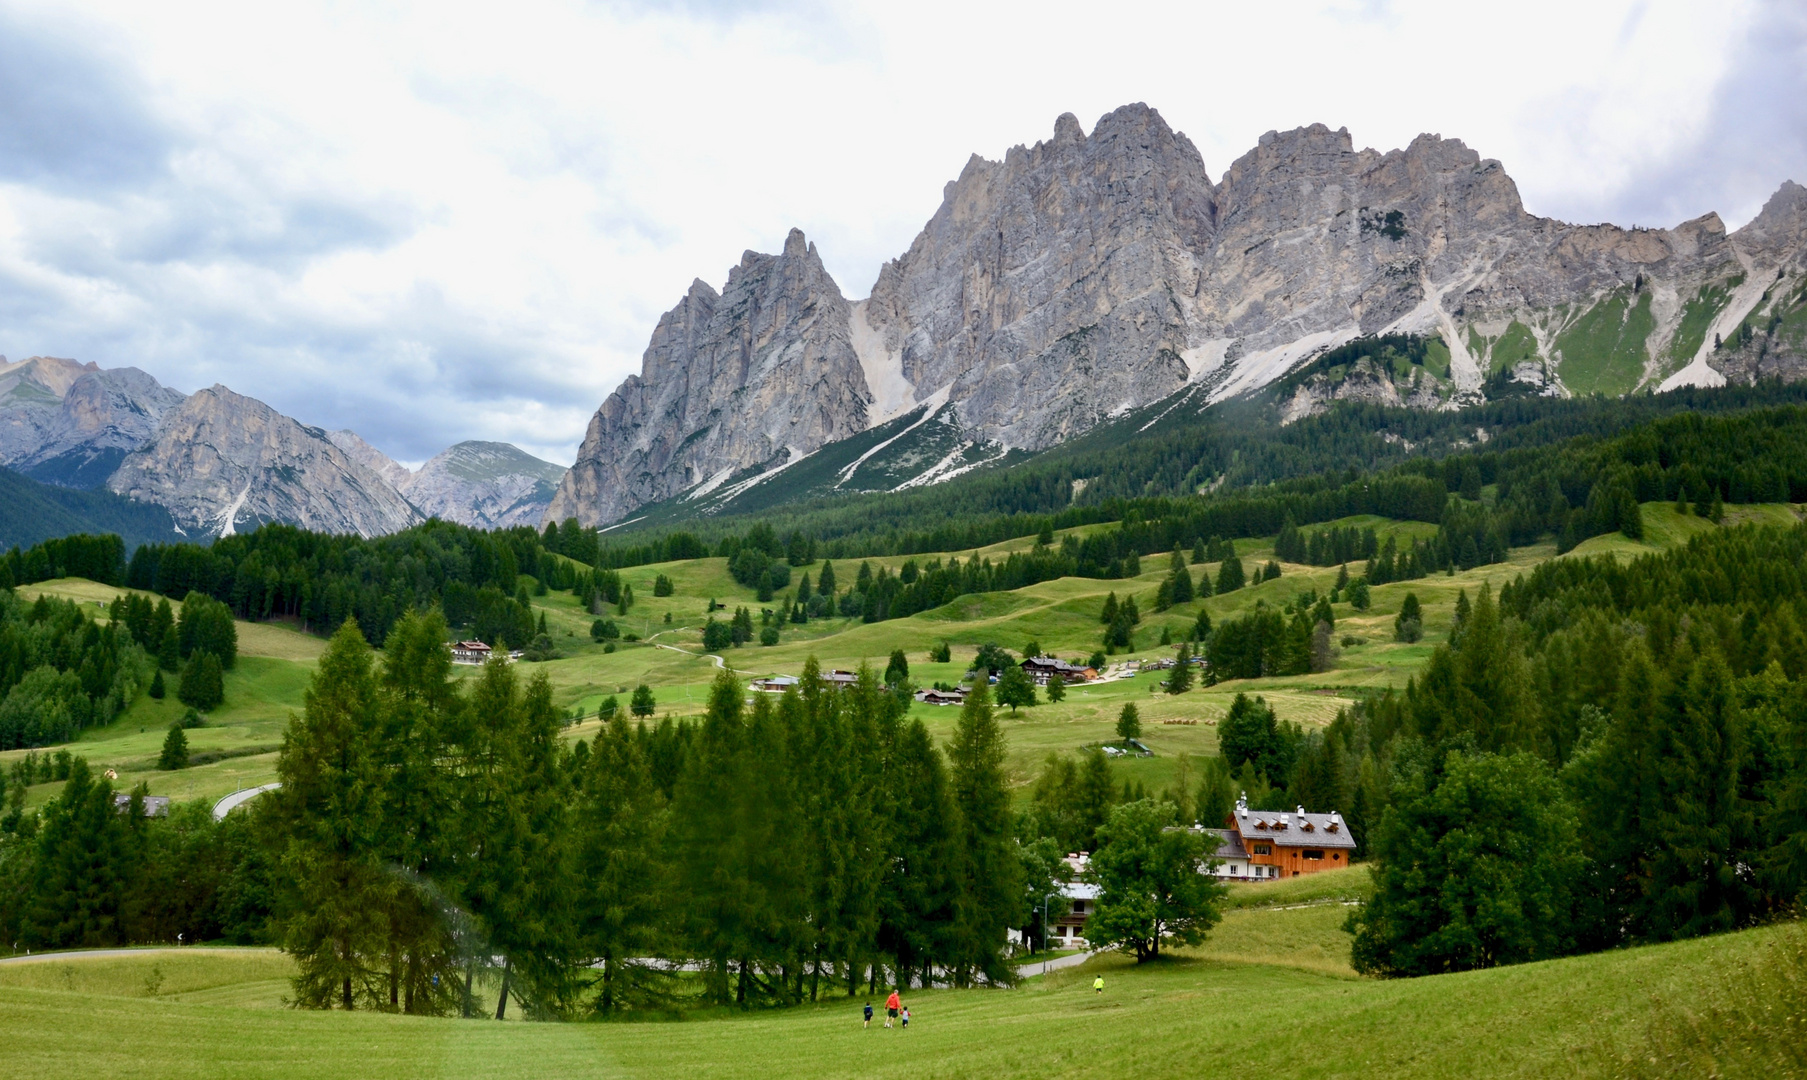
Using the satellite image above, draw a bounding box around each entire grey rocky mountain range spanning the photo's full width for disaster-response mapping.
[0,105,1807,536]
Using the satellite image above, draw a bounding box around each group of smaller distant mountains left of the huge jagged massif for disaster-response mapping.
[0,356,564,538]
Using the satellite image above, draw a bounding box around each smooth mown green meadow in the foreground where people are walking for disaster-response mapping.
[0,905,1807,1080]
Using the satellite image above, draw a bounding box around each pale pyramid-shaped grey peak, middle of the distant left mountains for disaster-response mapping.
[107,386,421,536]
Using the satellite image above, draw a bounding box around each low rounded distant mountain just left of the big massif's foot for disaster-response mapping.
[398,441,566,529]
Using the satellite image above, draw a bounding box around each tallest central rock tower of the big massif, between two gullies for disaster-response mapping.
[864,105,1216,450]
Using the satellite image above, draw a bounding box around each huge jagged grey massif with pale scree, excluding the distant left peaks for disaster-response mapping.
[548,105,1807,526]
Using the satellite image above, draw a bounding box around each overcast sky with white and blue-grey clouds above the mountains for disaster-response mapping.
[0,0,1807,462]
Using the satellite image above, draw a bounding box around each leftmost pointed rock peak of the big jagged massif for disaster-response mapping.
[546,229,873,526]
